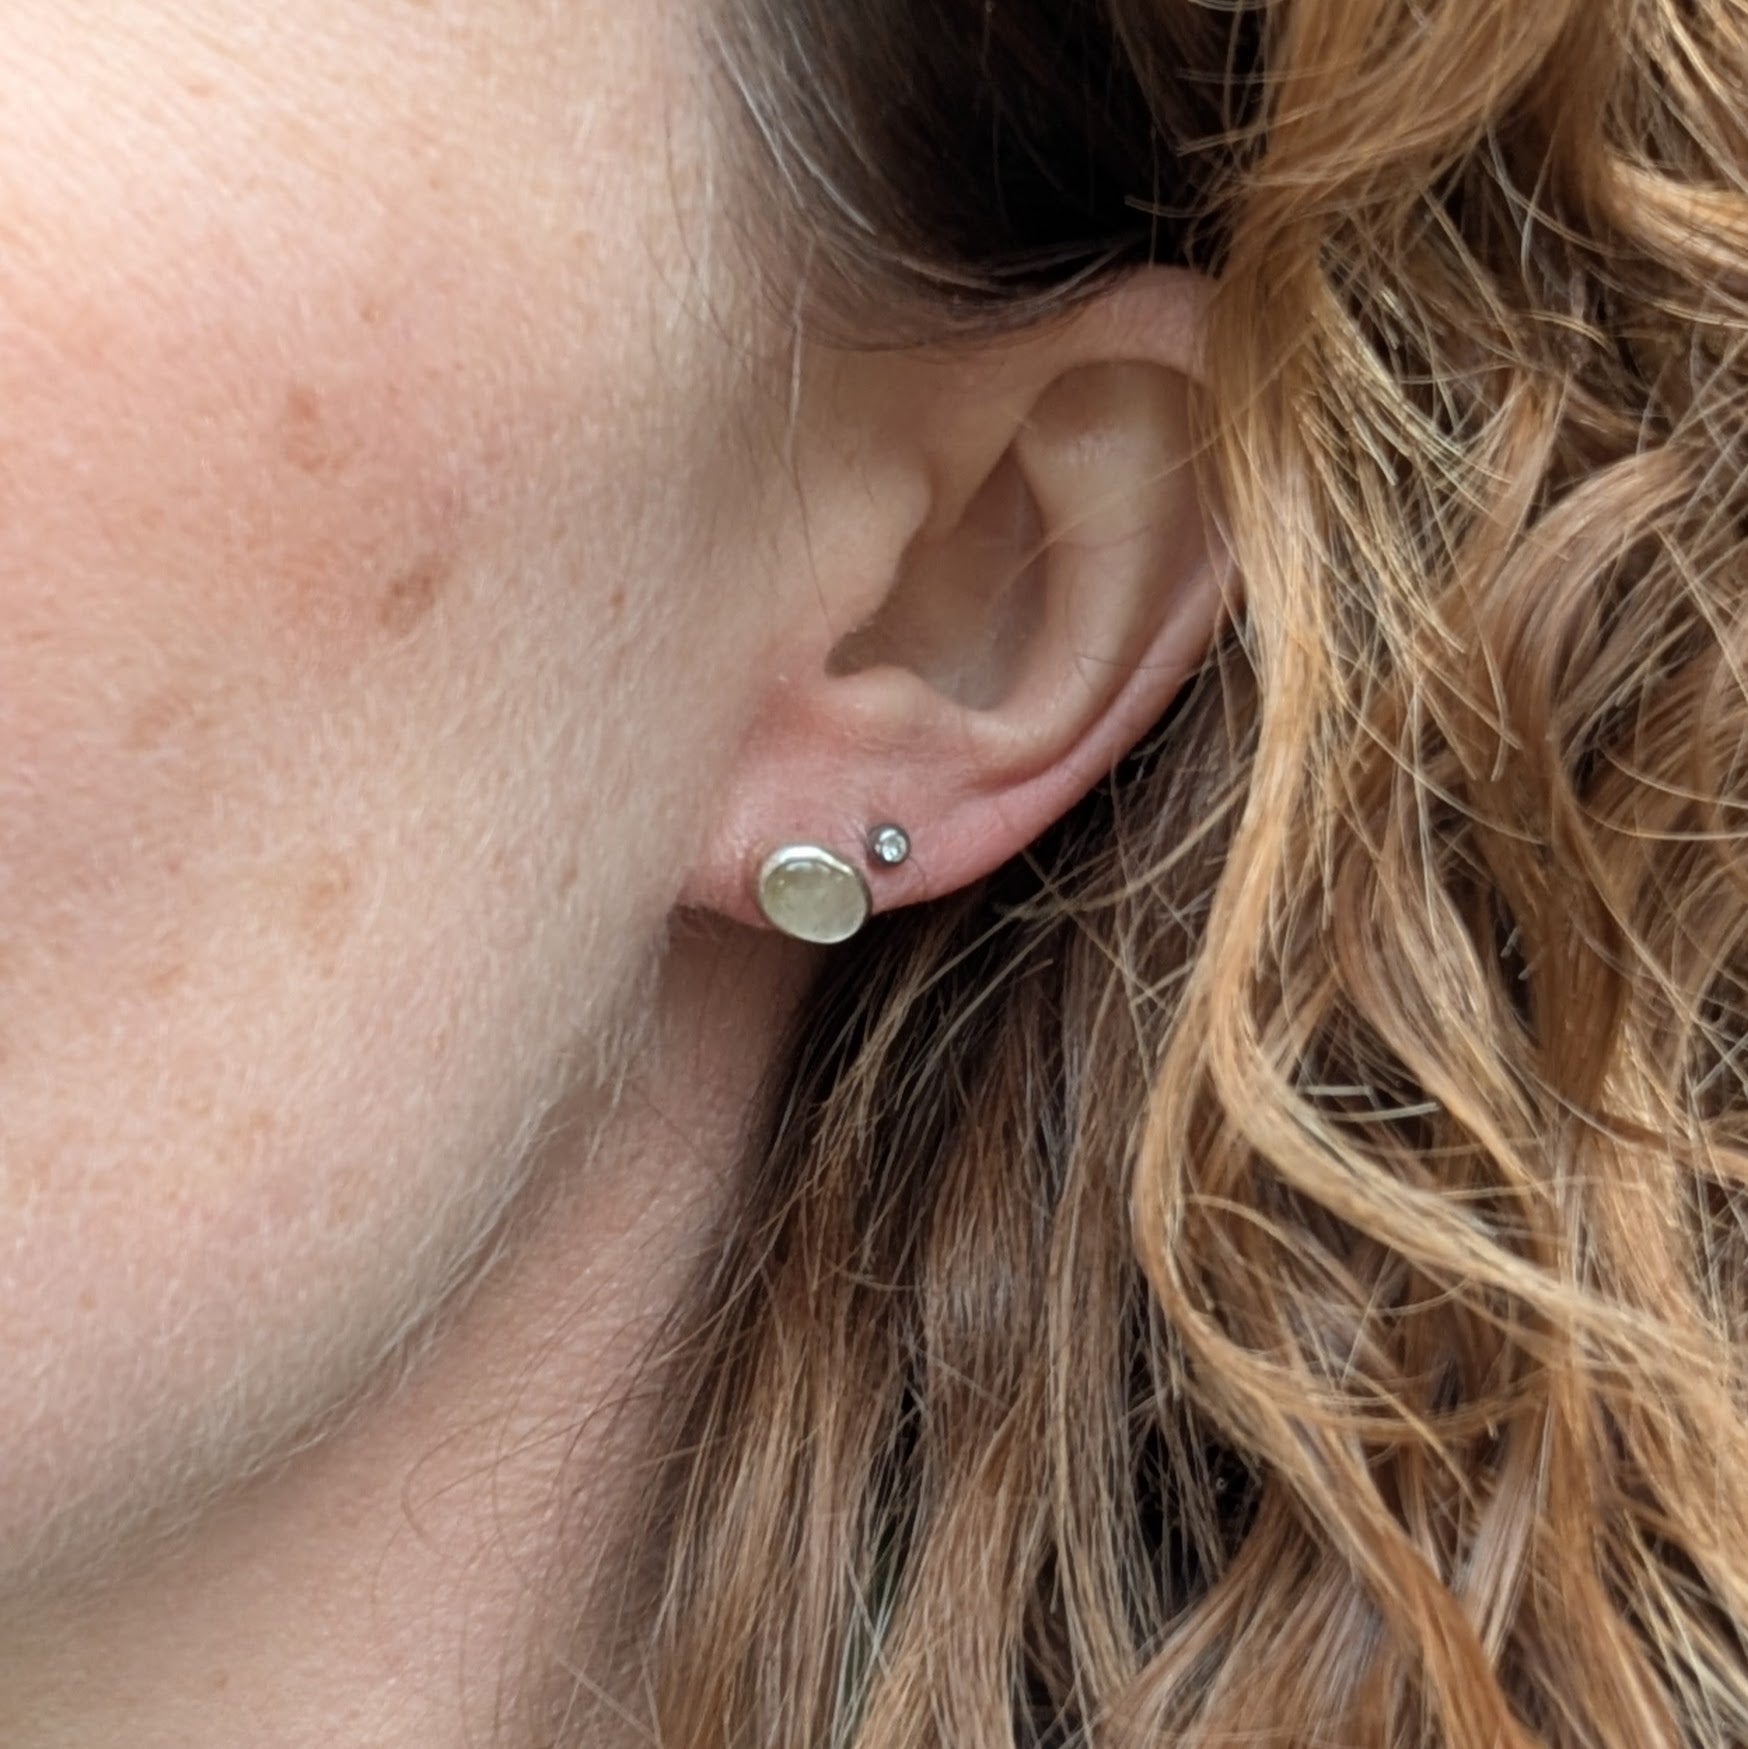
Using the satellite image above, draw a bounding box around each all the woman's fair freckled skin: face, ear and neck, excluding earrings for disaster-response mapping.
[0,0,1221,1749]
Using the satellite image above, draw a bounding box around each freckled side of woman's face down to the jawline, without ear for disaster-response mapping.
[0,0,780,1595]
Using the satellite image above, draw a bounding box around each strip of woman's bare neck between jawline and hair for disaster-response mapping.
[0,939,807,1749]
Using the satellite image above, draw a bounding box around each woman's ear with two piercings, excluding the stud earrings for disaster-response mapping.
[684,269,1230,922]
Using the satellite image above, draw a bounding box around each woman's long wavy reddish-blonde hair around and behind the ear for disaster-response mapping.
[566,0,1748,1749]
